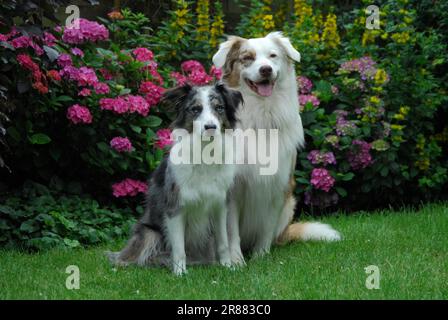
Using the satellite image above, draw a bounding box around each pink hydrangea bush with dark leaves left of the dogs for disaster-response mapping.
[2,11,176,197]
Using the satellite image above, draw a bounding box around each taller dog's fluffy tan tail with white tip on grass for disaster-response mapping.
[277,222,341,243]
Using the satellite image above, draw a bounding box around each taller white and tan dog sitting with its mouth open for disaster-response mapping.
[213,32,340,264]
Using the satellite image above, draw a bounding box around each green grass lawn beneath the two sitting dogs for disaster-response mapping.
[0,205,448,299]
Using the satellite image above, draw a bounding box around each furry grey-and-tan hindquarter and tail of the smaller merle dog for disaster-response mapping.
[106,225,163,266]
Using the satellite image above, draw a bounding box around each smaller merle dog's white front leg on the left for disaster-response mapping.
[166,212,187,276]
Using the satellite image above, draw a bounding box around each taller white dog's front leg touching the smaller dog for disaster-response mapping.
[227,199,246,266]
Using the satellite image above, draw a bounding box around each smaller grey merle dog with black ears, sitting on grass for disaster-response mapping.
[109,83,243,275]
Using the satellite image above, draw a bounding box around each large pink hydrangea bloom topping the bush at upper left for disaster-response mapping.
[62,18,109,44]
